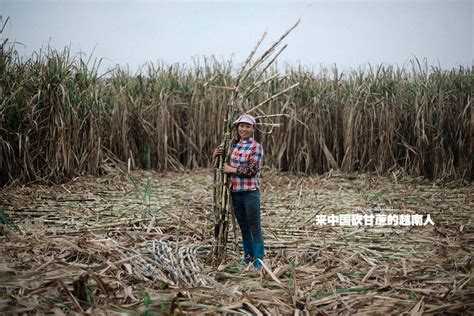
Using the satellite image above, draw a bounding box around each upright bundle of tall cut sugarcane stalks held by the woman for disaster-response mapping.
[211,20,300,264]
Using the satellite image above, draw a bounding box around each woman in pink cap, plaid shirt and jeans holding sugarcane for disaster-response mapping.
[214,114,264,269]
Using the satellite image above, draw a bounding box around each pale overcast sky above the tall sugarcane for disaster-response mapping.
[0,0,474,70]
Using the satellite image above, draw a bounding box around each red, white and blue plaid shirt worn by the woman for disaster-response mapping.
[230,138,263,192]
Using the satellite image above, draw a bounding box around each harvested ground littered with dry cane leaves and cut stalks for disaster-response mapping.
[0,170,474,315]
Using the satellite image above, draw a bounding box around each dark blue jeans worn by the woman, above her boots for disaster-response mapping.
[231,190,263,244]
